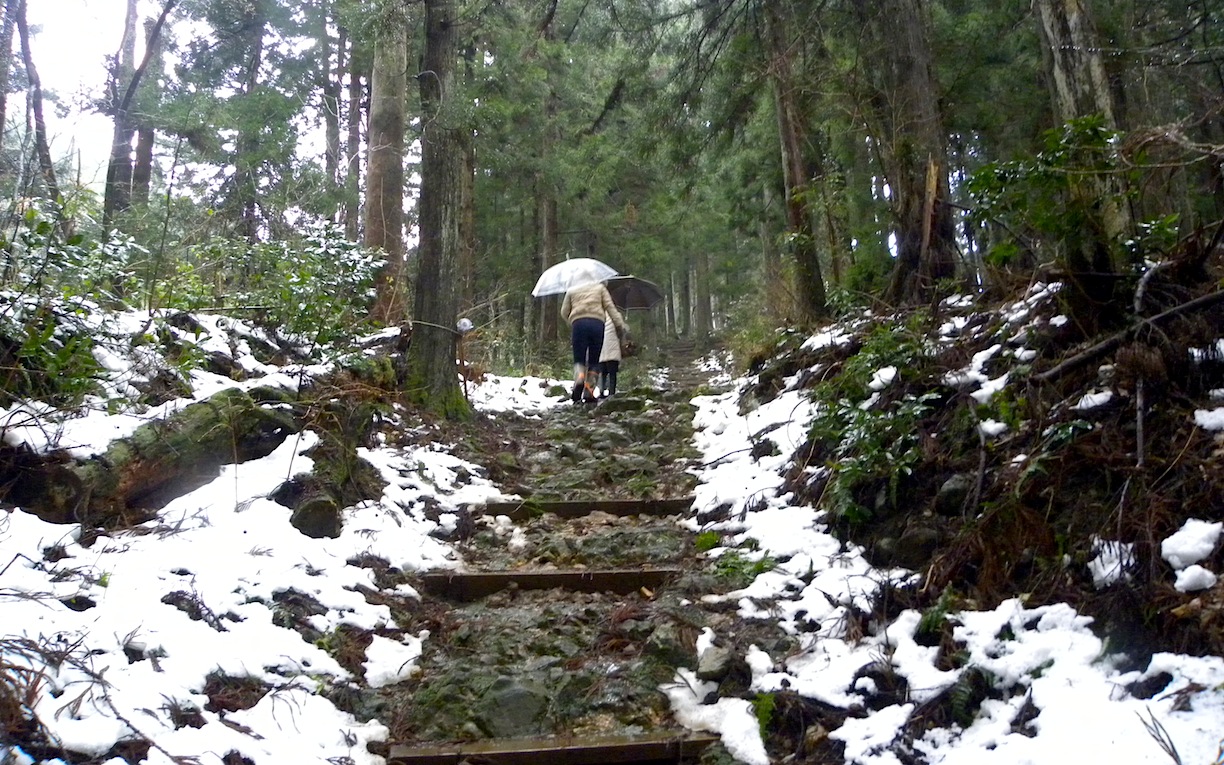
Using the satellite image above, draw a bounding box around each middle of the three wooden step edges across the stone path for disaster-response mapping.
[421,567,682,601]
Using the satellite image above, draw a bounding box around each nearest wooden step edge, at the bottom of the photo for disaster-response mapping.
[387,732,718,765]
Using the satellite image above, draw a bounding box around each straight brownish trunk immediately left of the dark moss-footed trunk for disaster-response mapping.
[365,2,408,324]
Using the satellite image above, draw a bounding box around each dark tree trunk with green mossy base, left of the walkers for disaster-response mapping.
[408,0,471,419]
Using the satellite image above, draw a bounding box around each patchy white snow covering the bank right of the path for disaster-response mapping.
[671,318,1224,765]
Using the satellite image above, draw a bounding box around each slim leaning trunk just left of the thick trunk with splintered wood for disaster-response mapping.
[764,0,827,323]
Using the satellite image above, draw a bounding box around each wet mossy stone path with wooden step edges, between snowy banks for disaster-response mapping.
[384,344,733,765]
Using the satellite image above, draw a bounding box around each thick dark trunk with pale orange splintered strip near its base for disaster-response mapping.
[858,0,957,304]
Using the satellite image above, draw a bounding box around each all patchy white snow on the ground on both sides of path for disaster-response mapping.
[7,312,1224,765]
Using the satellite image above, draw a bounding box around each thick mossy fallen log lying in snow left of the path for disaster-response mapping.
[9,388,300,528]
